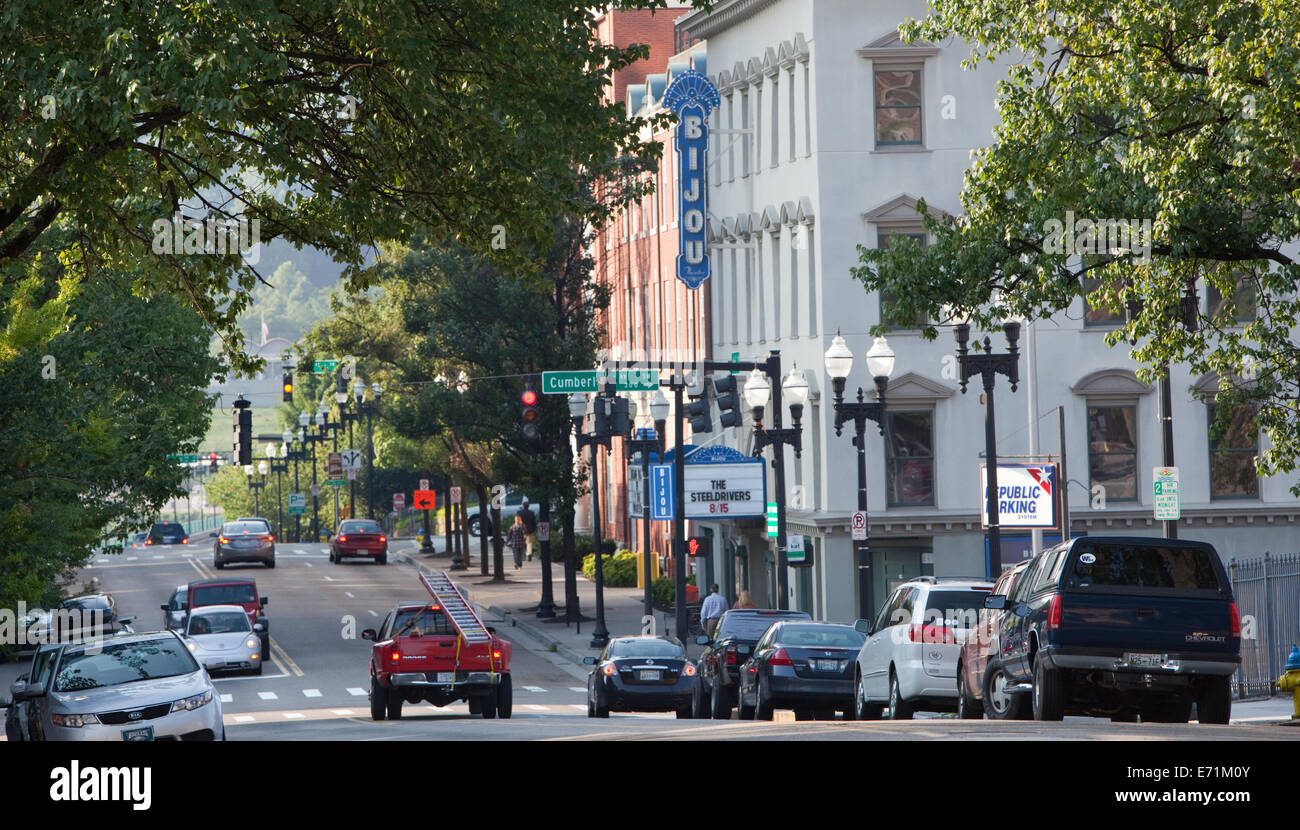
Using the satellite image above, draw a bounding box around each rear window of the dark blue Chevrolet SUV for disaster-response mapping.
[1069,544,1221,591]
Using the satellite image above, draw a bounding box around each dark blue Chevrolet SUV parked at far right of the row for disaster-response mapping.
[985,536,1242,723]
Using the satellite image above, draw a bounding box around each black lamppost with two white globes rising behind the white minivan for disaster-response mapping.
[826,333,894,619]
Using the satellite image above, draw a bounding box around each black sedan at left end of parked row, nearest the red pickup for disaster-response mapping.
[582,636,696,718]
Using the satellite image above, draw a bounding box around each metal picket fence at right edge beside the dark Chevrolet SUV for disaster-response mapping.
[1229,553,1300,697]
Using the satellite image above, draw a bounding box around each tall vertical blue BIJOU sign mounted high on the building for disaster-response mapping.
[663,69,720,289]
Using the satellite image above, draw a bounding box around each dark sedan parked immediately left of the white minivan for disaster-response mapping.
[740,621,866,721]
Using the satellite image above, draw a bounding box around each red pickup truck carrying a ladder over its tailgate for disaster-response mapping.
[361,574,512,721]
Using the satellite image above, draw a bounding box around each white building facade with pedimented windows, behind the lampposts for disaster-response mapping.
[676,0,1300,621]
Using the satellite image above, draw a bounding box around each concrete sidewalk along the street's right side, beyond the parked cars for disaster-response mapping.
[395,551,701,665]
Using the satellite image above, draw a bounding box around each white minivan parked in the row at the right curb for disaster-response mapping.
[854,576,993,721]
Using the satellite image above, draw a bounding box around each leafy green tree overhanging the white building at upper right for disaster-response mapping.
[854,0,1300,489]
